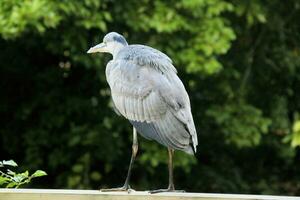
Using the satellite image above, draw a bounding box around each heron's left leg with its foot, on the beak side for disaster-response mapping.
[101,127,139,192]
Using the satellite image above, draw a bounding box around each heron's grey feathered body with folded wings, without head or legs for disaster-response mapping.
[106,47,198,153]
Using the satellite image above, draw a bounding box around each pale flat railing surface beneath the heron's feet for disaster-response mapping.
[0,189,300,200]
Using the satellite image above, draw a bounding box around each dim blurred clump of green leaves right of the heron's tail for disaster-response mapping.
[207,103,271,147]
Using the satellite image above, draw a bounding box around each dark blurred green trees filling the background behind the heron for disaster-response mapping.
[0,0,300,195]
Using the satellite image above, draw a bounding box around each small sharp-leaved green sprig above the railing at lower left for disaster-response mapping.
[0,160,47,188]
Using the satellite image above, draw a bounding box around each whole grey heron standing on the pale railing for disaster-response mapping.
[87,32,198,193]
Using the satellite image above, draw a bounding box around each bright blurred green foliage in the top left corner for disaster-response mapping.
[0,0,111,39]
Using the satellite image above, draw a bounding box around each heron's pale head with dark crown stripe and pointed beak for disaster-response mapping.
[87,32,128,55]
